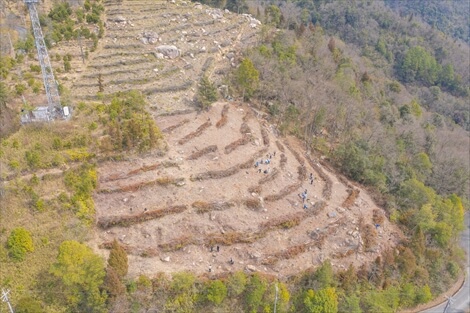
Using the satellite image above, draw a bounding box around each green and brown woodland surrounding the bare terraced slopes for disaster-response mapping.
[0,0,470,312]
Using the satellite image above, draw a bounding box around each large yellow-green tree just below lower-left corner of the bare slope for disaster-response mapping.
[50,241,106,312]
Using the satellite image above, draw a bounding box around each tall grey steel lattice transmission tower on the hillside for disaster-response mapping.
[24,0,64,119]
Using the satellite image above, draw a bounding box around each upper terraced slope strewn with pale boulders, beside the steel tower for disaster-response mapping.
[67,0,259,111]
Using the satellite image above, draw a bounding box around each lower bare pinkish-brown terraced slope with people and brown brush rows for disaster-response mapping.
[94,102,399,276]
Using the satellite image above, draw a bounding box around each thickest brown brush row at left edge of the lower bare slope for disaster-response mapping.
[98,205,188,229]
